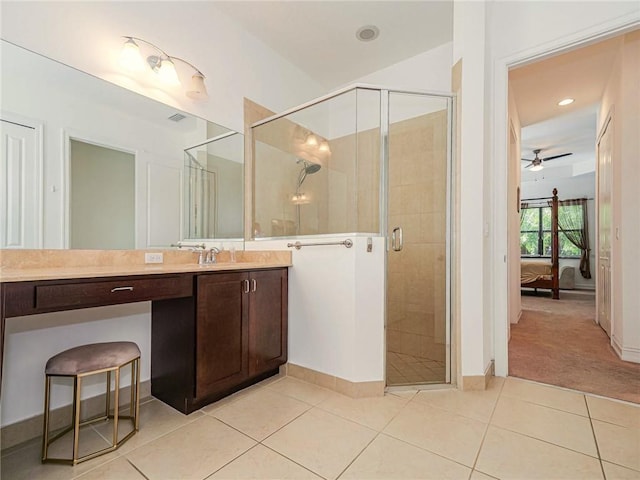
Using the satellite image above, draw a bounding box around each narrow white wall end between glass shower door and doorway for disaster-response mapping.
[451,2,490,377]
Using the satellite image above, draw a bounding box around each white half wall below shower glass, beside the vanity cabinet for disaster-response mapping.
[245,235,385,382]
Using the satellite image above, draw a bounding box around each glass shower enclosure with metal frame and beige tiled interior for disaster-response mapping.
[252,86,453,386]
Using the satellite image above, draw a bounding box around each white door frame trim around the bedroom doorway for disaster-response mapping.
[485,15,637,377]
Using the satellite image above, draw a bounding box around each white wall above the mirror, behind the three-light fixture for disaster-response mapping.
[0,1,324,131]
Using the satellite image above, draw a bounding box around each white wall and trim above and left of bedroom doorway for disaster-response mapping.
[484,1,640,375]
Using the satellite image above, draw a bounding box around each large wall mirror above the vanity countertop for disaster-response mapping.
[0,40,244,249]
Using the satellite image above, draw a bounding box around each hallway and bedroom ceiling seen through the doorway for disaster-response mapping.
[509,34,620,181]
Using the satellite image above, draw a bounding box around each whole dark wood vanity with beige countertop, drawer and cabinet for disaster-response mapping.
[0,252,291,414]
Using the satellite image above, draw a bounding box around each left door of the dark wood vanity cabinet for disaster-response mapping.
[195,272,249,398]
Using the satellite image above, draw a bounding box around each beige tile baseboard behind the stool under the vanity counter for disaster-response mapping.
[0,380,151,450]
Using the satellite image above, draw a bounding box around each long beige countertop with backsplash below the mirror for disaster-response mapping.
[0,250,291,283]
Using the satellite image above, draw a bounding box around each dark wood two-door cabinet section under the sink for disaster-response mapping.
[151,268,288,413]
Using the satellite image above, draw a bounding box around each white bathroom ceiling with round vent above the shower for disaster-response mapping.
[214,0,453,90]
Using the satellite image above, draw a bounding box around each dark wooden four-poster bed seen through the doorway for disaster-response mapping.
[520,188,560,300]
